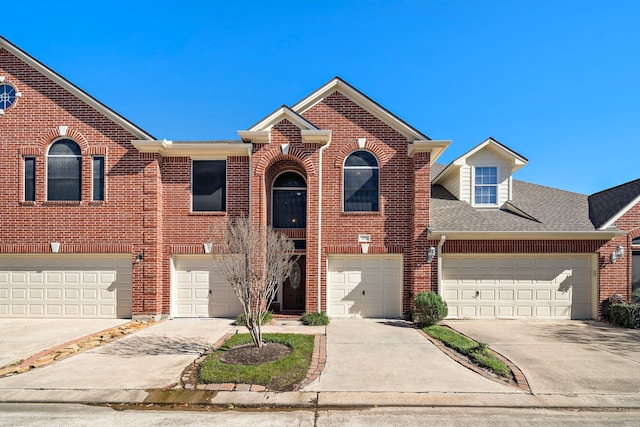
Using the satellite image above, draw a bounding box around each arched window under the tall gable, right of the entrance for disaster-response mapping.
[344,150,380,212]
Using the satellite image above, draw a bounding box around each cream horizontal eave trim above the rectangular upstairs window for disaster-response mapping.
[131,140,252,159]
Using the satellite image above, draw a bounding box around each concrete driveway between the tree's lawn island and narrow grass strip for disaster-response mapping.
[305,319,522,393]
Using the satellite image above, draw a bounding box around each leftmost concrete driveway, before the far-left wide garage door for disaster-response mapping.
[0,318,129,367]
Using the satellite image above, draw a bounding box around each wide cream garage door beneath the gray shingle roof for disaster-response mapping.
[442,254,595,319]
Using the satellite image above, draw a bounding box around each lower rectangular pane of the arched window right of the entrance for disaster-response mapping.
[344,169,379,212]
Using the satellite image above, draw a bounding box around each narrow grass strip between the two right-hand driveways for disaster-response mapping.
[422,325,511,378]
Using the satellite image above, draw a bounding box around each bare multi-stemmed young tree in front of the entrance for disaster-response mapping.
[216,217,296,347]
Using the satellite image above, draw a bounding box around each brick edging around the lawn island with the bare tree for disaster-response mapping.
[184,332,327,391]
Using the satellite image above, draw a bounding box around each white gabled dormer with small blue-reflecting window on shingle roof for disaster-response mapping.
[433,138,527,208]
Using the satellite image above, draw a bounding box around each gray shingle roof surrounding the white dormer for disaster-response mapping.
[430,170,595,232]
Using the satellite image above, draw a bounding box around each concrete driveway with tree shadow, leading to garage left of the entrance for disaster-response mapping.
[0,318,233,392]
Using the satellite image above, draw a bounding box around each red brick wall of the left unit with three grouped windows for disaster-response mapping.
[0,49,157,314]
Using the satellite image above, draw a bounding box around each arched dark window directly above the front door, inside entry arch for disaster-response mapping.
[271,172,307,228]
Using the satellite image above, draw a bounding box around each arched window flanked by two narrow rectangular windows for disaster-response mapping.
[47,139,82,201]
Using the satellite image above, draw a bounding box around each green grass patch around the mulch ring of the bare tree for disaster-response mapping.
[198,334,314,391]
